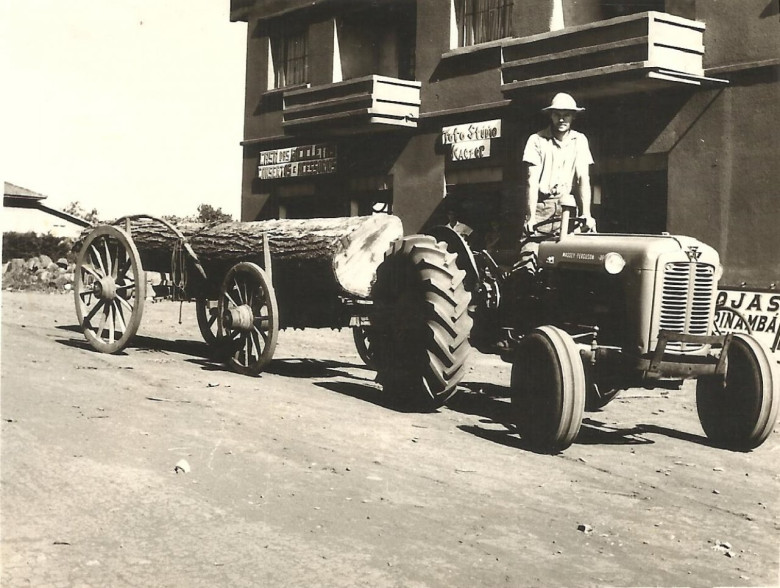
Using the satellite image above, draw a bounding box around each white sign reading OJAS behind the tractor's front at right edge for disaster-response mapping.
[715,289,780,362]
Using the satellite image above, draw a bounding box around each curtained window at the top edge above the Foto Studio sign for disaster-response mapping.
[455,0,513,47]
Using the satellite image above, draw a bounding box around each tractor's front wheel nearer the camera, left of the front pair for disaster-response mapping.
[511,326,585,452]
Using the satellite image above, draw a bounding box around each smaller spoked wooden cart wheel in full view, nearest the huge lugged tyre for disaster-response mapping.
[219,262,279,375]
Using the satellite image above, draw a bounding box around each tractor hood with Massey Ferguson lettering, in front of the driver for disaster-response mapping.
[539,233,720,271]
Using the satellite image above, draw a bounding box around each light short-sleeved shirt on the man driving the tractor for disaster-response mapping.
[523,127,593,196]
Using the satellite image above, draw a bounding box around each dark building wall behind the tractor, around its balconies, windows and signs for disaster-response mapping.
[235,0,780,287]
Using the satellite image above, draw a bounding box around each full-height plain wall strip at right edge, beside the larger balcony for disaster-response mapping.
[669,0,780,289]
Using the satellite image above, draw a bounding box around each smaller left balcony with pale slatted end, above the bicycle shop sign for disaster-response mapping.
[282,75,420,134]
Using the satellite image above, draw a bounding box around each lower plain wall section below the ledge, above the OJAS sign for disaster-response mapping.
[669,68,780,287]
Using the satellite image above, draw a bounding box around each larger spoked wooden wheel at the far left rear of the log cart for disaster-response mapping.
[73,226,146,353]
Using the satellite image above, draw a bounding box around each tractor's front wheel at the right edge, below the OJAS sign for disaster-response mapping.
[696,334,780,451]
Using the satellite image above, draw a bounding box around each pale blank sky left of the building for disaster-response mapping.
[0,0,247,220]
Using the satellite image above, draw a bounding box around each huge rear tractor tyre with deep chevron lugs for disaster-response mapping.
[370,235,472,408]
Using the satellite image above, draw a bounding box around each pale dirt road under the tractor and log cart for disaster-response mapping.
[0,292,780,587]
